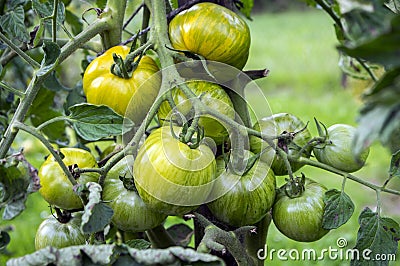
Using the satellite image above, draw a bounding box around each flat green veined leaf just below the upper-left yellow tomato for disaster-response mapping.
[68,103,133,141]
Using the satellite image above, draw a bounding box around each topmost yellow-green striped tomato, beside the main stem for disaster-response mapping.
[169,3,251,69]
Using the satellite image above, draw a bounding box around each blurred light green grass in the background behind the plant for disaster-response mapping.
[0,7,400,265]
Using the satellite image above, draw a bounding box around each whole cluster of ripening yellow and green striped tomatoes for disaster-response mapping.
[36,3,368,249]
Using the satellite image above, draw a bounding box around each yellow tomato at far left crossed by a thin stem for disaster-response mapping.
[38,148,98,210]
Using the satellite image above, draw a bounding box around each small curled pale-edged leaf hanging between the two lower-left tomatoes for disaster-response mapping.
[81,182,114,234]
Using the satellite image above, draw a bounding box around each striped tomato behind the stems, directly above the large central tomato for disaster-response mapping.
[158,81,235,145]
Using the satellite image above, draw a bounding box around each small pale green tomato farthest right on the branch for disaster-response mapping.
[313,124,369,173]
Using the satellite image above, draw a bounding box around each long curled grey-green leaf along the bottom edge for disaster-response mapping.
[7,244,225,266]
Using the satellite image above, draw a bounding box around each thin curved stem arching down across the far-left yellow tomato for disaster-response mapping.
[13,122,77,186]
